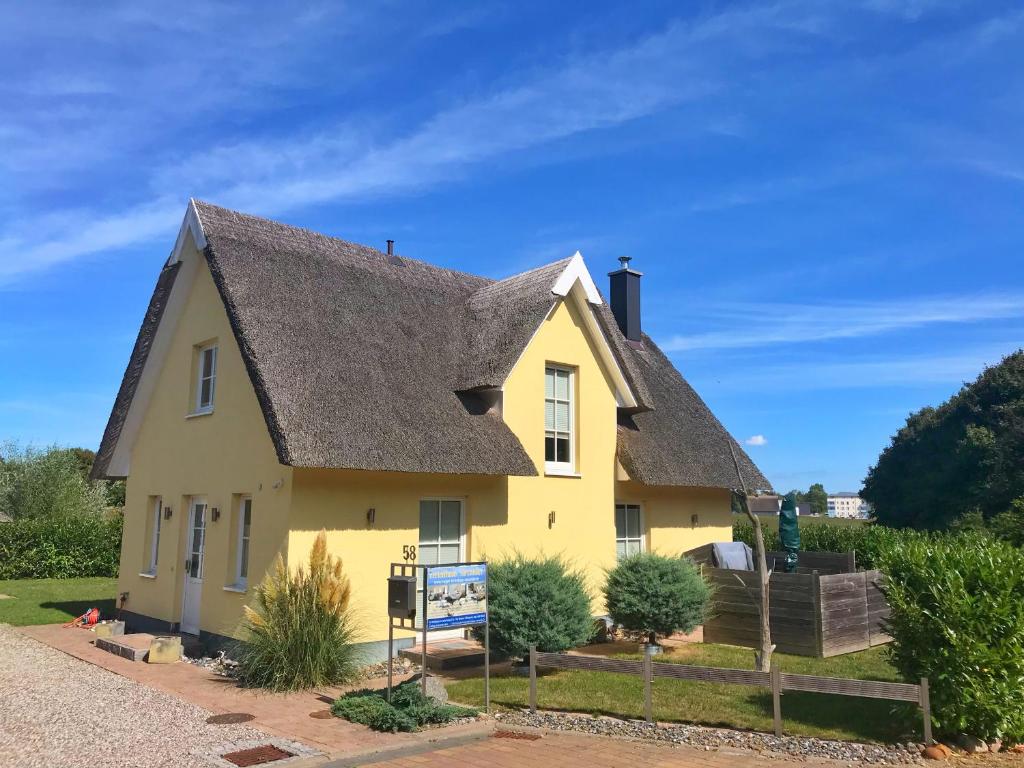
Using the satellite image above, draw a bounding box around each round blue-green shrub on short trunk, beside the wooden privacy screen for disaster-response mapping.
[604,553,711,645]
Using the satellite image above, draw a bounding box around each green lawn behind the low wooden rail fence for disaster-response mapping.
[447,643,921,742]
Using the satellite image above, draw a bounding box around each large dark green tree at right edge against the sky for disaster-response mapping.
[861,350,1024,528]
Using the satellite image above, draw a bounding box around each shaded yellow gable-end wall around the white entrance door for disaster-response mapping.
[118,241,292,635]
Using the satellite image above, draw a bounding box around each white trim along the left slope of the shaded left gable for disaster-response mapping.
[106,201,206,477]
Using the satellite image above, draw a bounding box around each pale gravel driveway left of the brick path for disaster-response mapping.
[0,625,280,768]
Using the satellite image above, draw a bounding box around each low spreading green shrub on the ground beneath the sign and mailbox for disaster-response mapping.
[331,681,477,733]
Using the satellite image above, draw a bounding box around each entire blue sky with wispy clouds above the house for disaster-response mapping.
[0,0,1024,490]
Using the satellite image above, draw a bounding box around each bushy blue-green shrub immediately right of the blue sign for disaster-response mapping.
[474,555,594,658]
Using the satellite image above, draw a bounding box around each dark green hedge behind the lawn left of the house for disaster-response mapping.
[0,514,123,579]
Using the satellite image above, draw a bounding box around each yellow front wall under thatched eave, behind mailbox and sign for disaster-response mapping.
[288,469,508,642]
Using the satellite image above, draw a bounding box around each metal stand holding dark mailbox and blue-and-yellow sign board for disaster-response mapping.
[387,561,490,712]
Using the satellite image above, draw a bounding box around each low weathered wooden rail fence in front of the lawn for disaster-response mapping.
[529,645,932,744]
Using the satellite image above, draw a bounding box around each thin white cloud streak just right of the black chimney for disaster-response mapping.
[660,294,1024,352]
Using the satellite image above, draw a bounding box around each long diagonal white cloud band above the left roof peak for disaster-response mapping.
[0,3,825,284]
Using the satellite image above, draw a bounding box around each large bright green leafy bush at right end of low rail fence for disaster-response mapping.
[880,534,1024,741]
